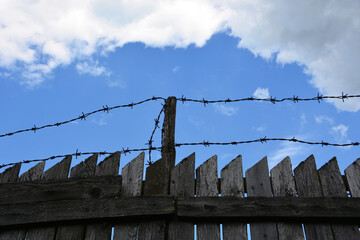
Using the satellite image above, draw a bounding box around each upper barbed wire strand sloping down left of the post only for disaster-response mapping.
[0,97,165,138]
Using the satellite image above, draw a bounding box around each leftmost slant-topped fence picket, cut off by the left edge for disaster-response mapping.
[0,163,26,240]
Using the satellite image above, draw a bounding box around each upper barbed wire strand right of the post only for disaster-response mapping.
[176,93,360,106]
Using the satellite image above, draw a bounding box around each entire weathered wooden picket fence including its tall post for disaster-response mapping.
[0,96,360,240]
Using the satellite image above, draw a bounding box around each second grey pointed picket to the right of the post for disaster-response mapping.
[196,155,220,240]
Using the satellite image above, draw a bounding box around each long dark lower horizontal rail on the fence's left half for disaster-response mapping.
[0,196,175,227]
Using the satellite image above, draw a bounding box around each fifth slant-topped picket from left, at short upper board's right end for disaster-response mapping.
[85,152,120,240]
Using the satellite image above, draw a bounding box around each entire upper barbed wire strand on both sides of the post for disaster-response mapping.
[0,93,360,138]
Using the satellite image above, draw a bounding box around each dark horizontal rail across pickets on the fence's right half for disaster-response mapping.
[176,197,360,222]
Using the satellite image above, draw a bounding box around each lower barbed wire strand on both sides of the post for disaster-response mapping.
[0,137,360,169]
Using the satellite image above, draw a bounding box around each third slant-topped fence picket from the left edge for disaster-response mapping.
[26,156,71,240]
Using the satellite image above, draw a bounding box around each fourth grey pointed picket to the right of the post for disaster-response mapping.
[245,157,277,239]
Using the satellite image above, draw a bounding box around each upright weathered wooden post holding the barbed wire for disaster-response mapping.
[161,97,176,193]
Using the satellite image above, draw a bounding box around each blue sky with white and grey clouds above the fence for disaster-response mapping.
[0,1,360,174]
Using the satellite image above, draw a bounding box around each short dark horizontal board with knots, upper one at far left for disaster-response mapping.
[0,176,121,205]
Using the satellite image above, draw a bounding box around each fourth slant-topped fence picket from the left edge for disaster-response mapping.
[55,154,98,240]
